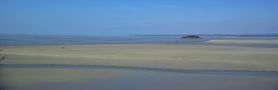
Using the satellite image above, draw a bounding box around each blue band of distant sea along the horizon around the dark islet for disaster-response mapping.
[0,34,278,47]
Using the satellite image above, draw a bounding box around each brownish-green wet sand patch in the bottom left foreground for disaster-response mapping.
[1,68,135,87]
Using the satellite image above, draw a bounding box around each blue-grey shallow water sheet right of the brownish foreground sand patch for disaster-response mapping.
[40,73,278,90]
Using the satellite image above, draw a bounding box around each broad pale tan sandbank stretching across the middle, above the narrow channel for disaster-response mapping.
[0,44,278,71]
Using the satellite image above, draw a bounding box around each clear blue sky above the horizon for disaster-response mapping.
[0,0,278,35]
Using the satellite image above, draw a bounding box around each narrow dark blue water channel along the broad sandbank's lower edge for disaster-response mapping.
[0,64,278,78]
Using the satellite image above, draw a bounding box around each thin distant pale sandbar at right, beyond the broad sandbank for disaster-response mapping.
[207,40,278,44]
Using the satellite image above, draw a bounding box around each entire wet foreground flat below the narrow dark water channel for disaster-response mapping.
[2,68,278,90]
